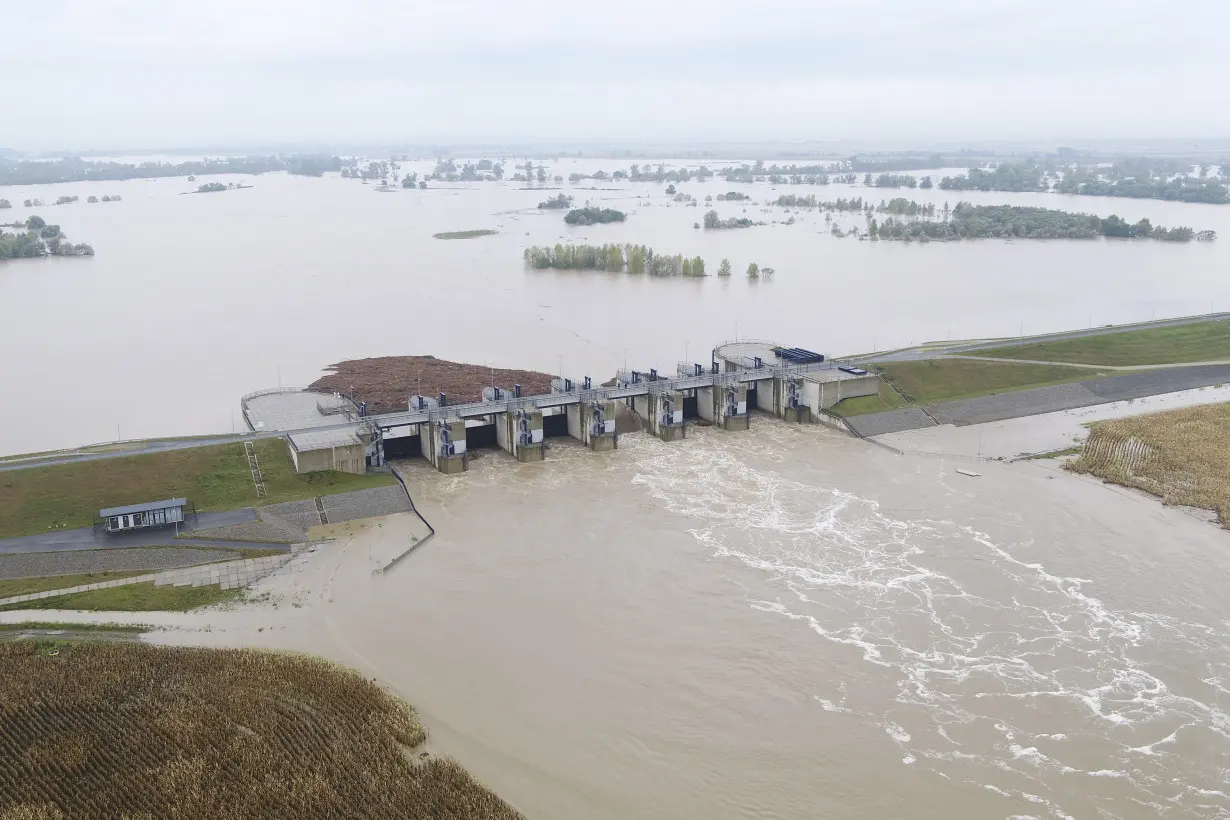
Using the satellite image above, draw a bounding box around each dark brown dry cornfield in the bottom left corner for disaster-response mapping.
[0,641,520,820]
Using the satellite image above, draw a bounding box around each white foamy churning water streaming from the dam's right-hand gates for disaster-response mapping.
[621,424,1230,818]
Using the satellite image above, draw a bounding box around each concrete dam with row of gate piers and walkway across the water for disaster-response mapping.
[241,339,879,473]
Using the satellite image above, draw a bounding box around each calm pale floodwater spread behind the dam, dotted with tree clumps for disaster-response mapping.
[0,160,1230,454]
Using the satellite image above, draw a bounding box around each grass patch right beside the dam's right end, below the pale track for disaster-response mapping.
[833,359,1113,416]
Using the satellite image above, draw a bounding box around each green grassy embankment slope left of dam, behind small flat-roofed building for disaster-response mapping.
[0,439,394,538]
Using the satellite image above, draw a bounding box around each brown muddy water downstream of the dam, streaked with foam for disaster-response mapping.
[48,417,1230,820]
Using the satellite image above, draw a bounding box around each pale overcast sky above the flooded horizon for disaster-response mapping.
[0,0,1230,150]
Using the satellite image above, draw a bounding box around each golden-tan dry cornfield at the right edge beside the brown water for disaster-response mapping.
[1068,403,1230,526]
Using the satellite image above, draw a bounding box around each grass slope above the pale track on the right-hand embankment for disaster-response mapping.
[969,320,1230,366]
